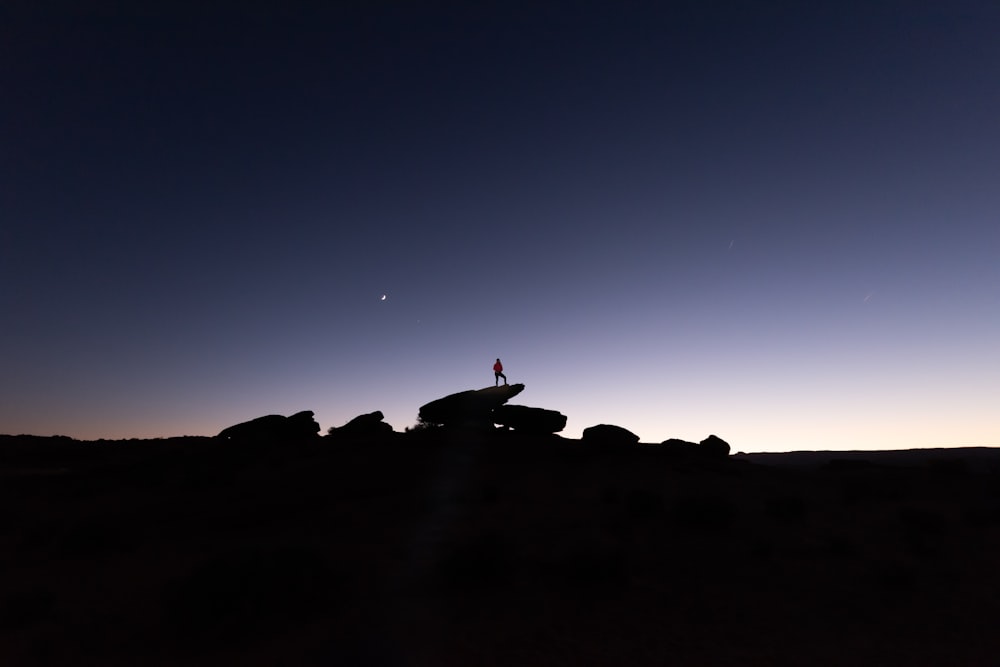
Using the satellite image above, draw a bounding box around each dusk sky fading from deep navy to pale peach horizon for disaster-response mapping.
[0,0,1000,452]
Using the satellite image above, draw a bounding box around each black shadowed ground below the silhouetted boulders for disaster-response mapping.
[0,428,1000,666]
